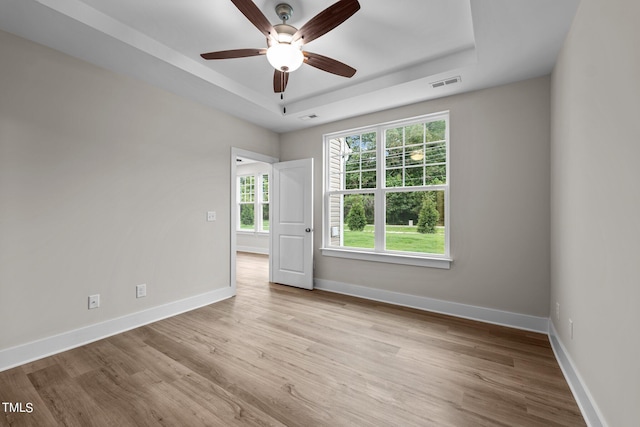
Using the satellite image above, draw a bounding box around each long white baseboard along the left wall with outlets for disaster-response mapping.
[0,286,234,372]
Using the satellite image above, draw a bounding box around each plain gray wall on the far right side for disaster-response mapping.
[551,0,640,426]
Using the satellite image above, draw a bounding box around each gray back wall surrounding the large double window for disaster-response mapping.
[280,77,550,317]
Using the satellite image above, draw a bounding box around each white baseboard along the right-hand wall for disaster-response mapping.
[549,321,607,427]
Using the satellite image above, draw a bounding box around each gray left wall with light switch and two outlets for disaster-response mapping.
[0,32,279,349]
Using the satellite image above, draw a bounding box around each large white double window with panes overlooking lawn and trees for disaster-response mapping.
[323,112,450,268]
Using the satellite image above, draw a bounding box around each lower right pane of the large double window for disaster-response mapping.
[385,191,445,255]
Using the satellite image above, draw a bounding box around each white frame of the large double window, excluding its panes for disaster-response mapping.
[320,111,453,269]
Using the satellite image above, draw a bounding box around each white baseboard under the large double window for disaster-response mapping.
[314,279,549,334]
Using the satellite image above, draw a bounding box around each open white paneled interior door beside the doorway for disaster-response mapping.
[270,159,313,289]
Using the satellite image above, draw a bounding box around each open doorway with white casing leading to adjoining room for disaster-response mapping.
[231,148,278,293]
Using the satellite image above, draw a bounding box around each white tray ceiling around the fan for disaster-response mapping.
[0,0,579,132]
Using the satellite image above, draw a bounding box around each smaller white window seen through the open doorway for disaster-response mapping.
[237,174,269,232]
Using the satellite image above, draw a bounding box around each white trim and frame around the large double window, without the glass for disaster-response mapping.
[320,111,453,269]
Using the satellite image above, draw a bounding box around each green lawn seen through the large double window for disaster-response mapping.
[344,225,444,254]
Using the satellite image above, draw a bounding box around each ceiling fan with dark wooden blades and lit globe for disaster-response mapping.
[200,0,360,93]
